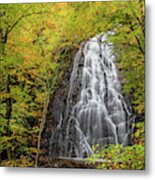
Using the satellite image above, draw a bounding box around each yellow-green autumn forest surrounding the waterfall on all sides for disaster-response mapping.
[0,0,145,170]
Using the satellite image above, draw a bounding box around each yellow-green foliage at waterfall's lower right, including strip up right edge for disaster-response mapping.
[87,122,145,170]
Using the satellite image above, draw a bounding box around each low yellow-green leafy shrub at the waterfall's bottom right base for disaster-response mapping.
[87,144,144,170]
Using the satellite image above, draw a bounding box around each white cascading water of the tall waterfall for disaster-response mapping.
[50,35,131,158]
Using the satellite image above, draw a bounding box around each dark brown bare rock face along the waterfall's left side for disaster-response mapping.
[40,46,77,161]
